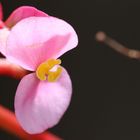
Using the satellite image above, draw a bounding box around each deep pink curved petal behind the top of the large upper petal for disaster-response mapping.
[5,6,48,28]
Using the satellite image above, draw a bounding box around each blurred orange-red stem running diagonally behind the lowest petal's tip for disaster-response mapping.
[0,105,60,140]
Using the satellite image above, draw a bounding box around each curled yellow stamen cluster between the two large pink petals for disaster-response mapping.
[36,59,62,82]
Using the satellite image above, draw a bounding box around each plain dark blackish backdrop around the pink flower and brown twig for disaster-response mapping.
[0,0,140,140]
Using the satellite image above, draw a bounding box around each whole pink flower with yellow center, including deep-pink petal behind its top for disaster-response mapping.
[0,7,78,134]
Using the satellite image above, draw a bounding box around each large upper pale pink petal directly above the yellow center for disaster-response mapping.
[6,16,78,70]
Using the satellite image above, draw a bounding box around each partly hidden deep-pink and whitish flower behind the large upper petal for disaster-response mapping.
[0,4,48,55]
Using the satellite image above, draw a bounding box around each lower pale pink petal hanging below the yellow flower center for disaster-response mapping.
[15,69,72,134]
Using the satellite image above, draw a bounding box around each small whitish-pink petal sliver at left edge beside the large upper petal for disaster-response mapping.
[0,28,10,55]
